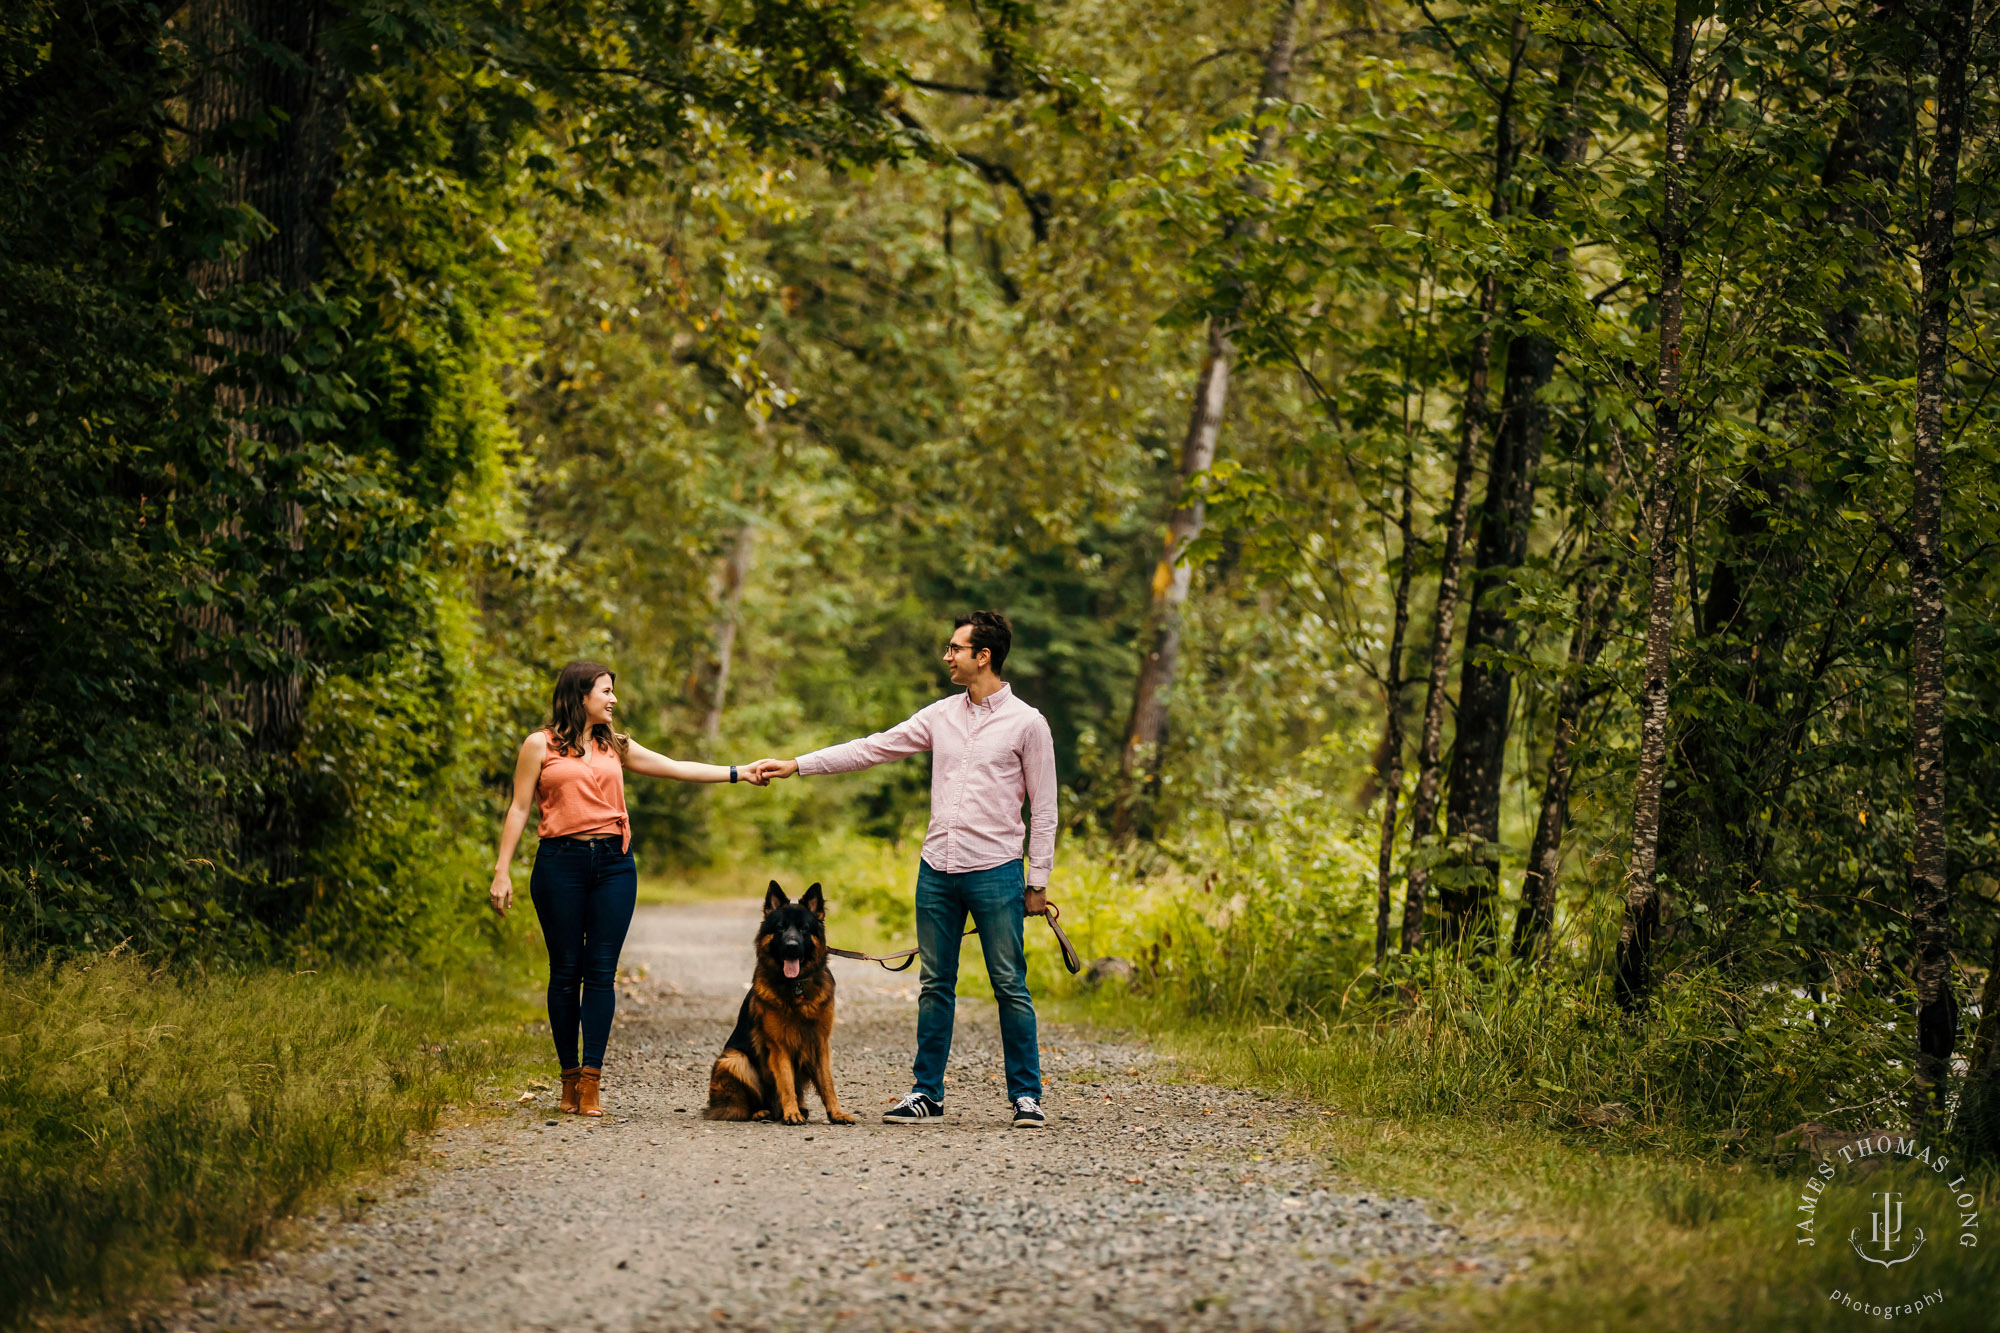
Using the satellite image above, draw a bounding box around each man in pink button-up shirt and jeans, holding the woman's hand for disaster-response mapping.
[752,610,1056,1129]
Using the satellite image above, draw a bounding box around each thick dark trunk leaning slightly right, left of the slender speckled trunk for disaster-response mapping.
[1438,46,1588,953]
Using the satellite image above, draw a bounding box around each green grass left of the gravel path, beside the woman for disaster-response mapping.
[0,953,546,1327]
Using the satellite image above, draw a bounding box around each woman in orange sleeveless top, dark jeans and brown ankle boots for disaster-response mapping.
[490,662,768,1115]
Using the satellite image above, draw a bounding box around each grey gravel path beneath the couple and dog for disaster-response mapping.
[148,903,1510,1333]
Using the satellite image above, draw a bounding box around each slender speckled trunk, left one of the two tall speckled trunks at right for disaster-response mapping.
[1616,0,1698,1007]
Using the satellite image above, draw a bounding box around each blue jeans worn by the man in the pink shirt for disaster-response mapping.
[912,861,1042,1103]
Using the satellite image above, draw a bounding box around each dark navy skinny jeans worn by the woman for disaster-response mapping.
[528,839,638,1069]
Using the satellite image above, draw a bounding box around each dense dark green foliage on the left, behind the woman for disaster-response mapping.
[0,0,908,957]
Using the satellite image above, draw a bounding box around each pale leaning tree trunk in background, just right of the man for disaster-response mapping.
[1112,0,1298,841]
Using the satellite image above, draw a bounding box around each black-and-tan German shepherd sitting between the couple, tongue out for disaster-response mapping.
[702,881,854,1125]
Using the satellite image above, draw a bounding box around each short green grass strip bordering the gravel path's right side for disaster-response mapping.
[1054,995,2000,1333]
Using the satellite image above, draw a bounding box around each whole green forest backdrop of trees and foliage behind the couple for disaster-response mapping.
[0,0,2000,1288]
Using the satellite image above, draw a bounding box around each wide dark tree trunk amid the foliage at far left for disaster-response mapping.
[186,0,348,904]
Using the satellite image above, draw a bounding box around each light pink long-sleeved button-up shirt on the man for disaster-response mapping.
[798,685,1056,889]
